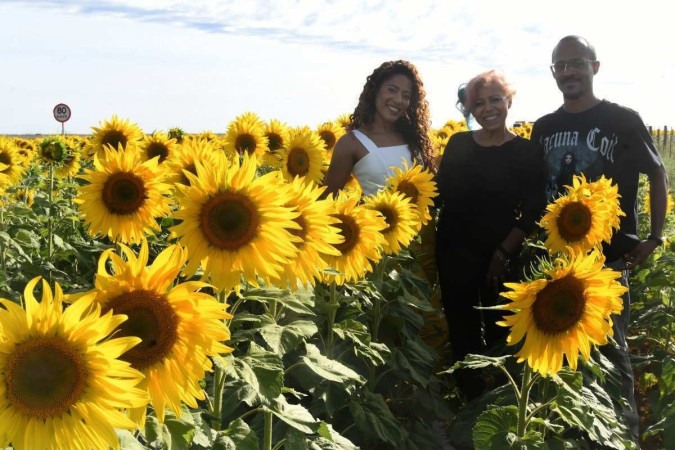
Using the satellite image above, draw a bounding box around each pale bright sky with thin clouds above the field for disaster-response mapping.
[0,0,675,134]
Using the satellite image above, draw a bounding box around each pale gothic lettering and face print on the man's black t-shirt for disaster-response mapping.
[541,127,619,199]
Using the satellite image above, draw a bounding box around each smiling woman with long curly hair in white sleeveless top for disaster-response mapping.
[325,61,434,195]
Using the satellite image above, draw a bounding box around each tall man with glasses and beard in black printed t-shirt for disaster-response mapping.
[531,36,668,442]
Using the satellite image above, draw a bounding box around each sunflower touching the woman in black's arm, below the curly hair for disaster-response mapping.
[387,164,438,226]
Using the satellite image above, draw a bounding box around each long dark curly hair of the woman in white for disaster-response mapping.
[347,60,435,171]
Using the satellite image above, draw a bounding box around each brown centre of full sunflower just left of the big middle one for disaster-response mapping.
[101,172,147,215]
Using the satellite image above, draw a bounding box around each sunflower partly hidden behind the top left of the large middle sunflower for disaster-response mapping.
[163,139,229,186]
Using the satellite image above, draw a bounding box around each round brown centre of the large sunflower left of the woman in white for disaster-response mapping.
[199,192,260,251]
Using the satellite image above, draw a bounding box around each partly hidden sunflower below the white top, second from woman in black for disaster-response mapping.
[364,191,420,255]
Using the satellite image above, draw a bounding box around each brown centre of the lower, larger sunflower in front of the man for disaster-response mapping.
[532,275,586,335]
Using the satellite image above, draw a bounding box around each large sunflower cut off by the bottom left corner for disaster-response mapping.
[0,277,148,450]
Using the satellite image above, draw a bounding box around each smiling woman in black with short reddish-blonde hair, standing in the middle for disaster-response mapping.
[436,71,546,399]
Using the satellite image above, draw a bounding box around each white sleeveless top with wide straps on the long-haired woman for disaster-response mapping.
[352,130,412,196]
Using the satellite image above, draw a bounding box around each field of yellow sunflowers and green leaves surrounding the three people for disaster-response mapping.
[0,116,675,450]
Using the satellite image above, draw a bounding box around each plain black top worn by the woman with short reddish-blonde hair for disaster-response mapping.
[436,132,546,250]
